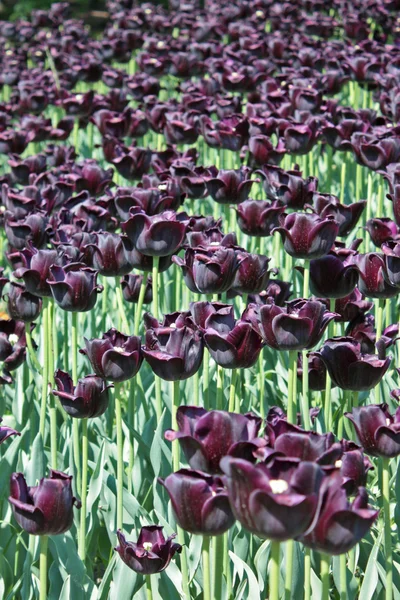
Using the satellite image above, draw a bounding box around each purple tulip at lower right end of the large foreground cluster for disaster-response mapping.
[300,470,379,555]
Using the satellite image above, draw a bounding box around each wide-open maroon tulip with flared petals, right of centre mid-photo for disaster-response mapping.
[242,299,335,350]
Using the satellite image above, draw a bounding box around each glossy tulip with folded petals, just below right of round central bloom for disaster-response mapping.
[172,244,240,294]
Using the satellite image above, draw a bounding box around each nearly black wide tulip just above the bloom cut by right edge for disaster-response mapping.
[317,337,391,392]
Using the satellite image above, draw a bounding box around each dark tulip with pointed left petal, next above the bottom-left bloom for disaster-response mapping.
[53,369,112,419]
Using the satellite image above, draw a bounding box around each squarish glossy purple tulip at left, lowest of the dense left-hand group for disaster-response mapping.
[47,263,103,312]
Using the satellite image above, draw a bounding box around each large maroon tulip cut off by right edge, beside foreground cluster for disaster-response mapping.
[345,404,400,458]
